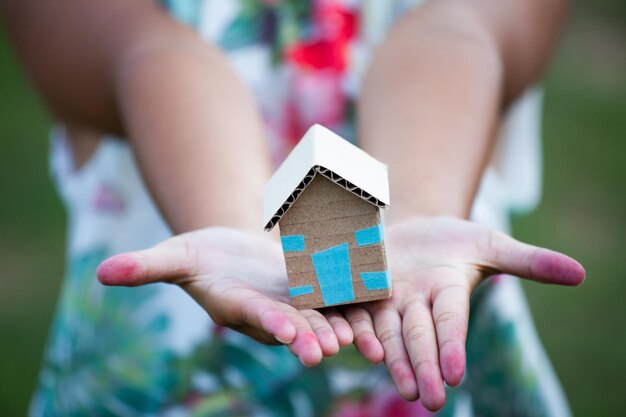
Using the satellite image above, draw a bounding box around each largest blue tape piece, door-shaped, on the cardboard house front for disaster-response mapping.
[311,242,354,306]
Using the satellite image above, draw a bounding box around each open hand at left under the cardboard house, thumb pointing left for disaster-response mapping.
[97,228,352,366]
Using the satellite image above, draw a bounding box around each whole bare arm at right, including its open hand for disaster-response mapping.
[347,0,584,410]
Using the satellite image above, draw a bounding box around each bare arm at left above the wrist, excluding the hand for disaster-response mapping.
[0,0,270,232]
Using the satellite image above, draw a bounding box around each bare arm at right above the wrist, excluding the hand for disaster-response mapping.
[359,0,562,221]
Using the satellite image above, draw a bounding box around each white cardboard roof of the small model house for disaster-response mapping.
[263,124,389,230]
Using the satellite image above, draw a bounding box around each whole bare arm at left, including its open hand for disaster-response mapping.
[0,0,351,365]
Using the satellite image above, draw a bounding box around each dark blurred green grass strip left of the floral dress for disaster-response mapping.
[0,17,65,417]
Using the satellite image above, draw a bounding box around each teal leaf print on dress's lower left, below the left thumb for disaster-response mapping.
[37,249,178,417]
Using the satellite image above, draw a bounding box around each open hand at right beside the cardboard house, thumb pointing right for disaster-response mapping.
[344,217,585,411]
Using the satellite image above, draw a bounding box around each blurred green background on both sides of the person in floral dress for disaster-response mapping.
[0,0,626,417]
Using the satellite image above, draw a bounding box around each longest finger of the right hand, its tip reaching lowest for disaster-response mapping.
[402,299,446,411]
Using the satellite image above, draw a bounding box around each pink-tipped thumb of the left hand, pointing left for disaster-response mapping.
[96,236,196,287]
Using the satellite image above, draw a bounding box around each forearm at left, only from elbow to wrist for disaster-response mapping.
[116,33,270,232]
